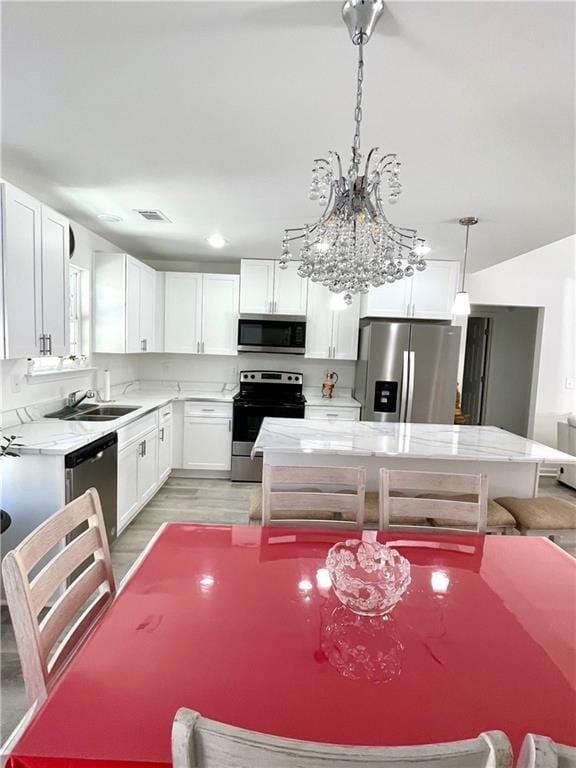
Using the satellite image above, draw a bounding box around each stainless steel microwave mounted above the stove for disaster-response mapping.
[238,315,306,355]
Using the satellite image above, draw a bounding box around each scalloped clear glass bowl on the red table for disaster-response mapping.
[326,539,410,616]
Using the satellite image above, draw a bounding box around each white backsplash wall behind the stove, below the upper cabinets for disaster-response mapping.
[138,353,356,392]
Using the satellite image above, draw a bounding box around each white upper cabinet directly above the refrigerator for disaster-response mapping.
[361,259,460,320]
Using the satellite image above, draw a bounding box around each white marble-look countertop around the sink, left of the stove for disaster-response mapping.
[0,390,236,456]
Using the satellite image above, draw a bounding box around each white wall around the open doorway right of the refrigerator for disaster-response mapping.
[467,235,576,447]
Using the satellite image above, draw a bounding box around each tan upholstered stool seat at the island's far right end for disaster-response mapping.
[496,496,576,538]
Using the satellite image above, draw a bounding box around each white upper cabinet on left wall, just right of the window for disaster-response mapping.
[92,253,156,353]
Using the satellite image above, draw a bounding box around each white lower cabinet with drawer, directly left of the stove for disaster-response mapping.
[182,403,232,472]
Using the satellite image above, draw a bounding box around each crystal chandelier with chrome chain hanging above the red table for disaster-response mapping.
[279,0,430,304]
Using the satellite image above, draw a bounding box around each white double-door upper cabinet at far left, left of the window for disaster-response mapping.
[0,183,69,358]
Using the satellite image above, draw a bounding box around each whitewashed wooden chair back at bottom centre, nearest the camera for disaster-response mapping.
[172,708,512,768]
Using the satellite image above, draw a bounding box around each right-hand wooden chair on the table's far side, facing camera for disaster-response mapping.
[380,467,488,533]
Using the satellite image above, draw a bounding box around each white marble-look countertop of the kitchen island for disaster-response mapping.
[252,418,576,464]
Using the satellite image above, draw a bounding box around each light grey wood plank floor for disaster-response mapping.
[0,477,576,743]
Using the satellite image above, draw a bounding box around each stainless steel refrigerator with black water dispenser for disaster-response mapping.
[354,320,460,424]
